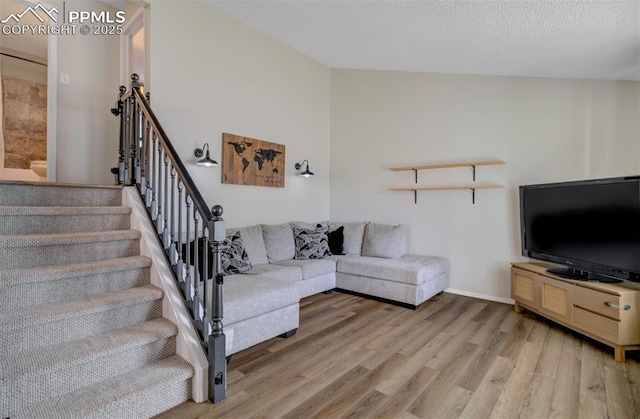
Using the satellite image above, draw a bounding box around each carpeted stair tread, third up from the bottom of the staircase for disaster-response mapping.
[0,285,163,330]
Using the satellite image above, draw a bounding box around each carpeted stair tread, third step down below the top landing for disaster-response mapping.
[0,256,151,289]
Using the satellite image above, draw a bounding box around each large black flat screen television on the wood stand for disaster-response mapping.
[520,176,640,282]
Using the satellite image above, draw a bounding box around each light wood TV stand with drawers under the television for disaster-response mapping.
[511,263,640,362]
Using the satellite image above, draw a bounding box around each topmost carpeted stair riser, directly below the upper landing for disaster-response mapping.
[0,183,122,207]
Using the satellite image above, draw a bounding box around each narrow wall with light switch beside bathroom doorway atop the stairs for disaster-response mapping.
[56,1,120,185]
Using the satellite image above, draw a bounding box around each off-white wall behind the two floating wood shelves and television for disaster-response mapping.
[330,69,640,299]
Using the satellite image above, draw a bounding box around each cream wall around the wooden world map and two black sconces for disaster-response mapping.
[150,1,330,226]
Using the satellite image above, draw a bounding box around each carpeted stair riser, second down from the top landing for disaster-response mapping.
[0,214,130,236]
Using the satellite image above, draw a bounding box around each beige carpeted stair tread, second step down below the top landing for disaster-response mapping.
[0,229,141,248]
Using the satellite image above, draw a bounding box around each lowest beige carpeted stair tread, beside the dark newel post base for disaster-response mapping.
[14,355,193,418]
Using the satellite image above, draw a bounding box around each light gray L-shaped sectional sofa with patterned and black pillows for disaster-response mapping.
[210,222,448,356]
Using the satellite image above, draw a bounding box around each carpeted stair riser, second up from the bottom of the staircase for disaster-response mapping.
[0,336,176,418]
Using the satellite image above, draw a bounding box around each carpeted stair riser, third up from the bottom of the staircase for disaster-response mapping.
[0,300,162,355]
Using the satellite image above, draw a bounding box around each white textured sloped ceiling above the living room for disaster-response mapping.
[213,0,640,80]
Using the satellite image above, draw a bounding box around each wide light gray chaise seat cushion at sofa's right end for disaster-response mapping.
[337,255,449,285]
